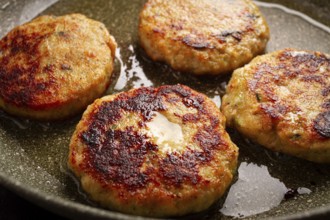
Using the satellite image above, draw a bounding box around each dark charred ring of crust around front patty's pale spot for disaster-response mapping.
[80,85,227,191]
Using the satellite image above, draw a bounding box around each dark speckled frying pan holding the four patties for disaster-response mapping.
[0,0,330,219]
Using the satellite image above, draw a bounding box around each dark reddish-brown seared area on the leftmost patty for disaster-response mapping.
[0,28,57,110]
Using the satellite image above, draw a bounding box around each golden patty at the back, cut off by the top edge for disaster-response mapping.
[139,0,269,75]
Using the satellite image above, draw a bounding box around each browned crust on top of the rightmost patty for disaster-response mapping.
[249,49,330,139]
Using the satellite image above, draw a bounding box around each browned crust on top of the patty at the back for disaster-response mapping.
[140,1,261,50]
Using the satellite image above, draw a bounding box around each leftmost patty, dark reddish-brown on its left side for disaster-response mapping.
[0,14,116,120]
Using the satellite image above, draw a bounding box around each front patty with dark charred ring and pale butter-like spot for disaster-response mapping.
[68,85,238,217]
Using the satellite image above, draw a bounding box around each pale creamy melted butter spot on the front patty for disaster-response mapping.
[146,112,184,153]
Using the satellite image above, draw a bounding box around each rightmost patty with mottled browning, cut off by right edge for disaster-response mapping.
[222,49,330,163]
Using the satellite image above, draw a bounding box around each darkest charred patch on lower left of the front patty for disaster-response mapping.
[84,128,157,190]
